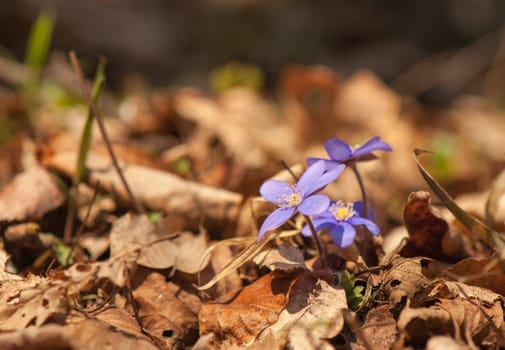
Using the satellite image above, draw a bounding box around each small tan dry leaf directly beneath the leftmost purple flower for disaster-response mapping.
[253,245,307,272]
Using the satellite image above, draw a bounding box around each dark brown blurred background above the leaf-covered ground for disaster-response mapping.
[0,0,505,104]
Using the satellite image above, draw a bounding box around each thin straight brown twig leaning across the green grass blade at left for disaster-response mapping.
[69,51,145,214]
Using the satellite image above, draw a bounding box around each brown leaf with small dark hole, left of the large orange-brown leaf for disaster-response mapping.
[133,273,201,348]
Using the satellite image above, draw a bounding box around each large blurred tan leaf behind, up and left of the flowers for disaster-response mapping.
[174,89,297,169]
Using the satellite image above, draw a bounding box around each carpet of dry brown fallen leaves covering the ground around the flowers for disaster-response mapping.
[0,48,505,349]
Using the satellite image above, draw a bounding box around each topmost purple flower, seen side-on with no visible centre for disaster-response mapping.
[307,136,392,167]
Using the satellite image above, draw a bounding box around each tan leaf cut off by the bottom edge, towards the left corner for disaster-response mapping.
[65,308,159,350]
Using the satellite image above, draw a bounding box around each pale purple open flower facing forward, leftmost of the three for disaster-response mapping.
[258,161,344,241]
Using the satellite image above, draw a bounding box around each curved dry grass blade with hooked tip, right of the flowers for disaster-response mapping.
[413,148,505,260]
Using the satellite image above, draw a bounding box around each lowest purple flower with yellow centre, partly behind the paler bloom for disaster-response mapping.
[302,201,380,248]
